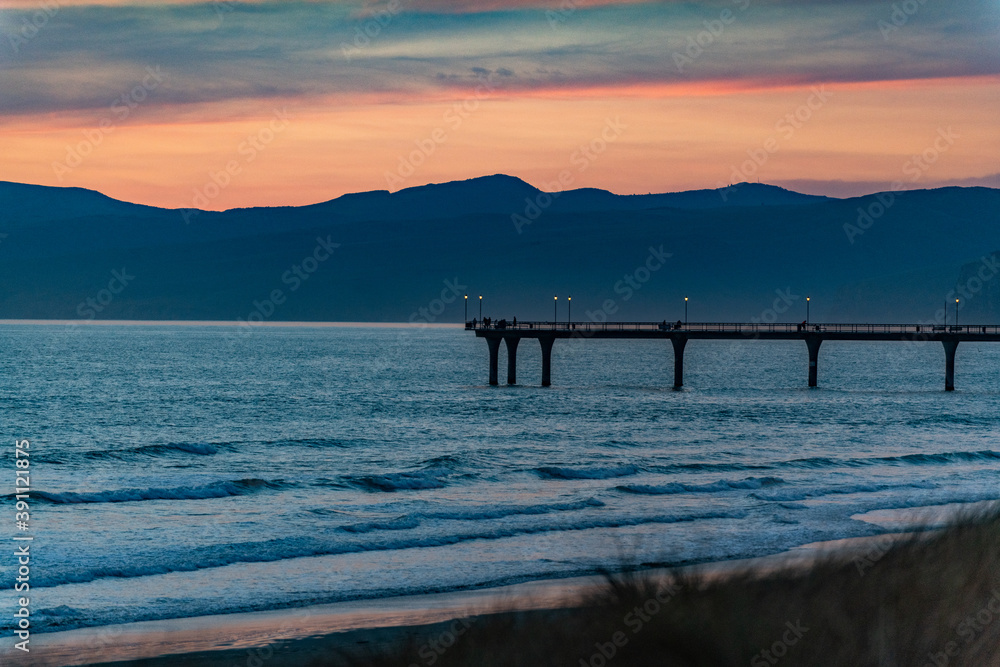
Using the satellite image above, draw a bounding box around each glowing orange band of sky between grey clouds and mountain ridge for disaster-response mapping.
[0,73,1000,209]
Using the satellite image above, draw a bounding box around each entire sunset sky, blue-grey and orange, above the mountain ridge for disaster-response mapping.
[0,0,1000,210]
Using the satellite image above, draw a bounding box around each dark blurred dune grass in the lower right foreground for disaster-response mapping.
[334,509,1000,667]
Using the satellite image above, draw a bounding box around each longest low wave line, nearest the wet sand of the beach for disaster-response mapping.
[19,511,748,588]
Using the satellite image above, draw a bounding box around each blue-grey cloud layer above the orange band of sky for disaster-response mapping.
[0,0,1000,115]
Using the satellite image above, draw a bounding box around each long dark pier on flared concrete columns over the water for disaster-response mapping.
[465,320,1000,391]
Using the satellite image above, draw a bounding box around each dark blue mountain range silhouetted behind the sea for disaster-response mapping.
[0,175,1000,323]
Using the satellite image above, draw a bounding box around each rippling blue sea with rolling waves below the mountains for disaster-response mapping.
[0,324,1000,632]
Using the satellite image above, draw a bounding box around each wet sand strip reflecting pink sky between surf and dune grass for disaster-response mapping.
[0,532,907,667]
